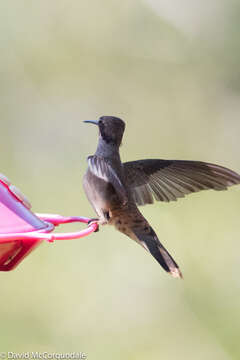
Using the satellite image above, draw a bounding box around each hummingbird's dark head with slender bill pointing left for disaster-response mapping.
[84,116,125,146]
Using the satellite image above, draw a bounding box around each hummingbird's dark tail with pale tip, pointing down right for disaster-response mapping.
[131,225,182,278]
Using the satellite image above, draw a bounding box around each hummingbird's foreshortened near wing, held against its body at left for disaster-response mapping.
[88,155,127,203]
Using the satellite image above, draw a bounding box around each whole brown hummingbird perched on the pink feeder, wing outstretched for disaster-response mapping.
[83,116,240,278]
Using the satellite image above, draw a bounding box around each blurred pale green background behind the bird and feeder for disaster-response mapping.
[0,0,240,360]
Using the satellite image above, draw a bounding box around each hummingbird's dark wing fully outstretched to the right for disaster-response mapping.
[123,159,240,205]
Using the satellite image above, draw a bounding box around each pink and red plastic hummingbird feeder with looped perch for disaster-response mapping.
[0,174,98,271]
